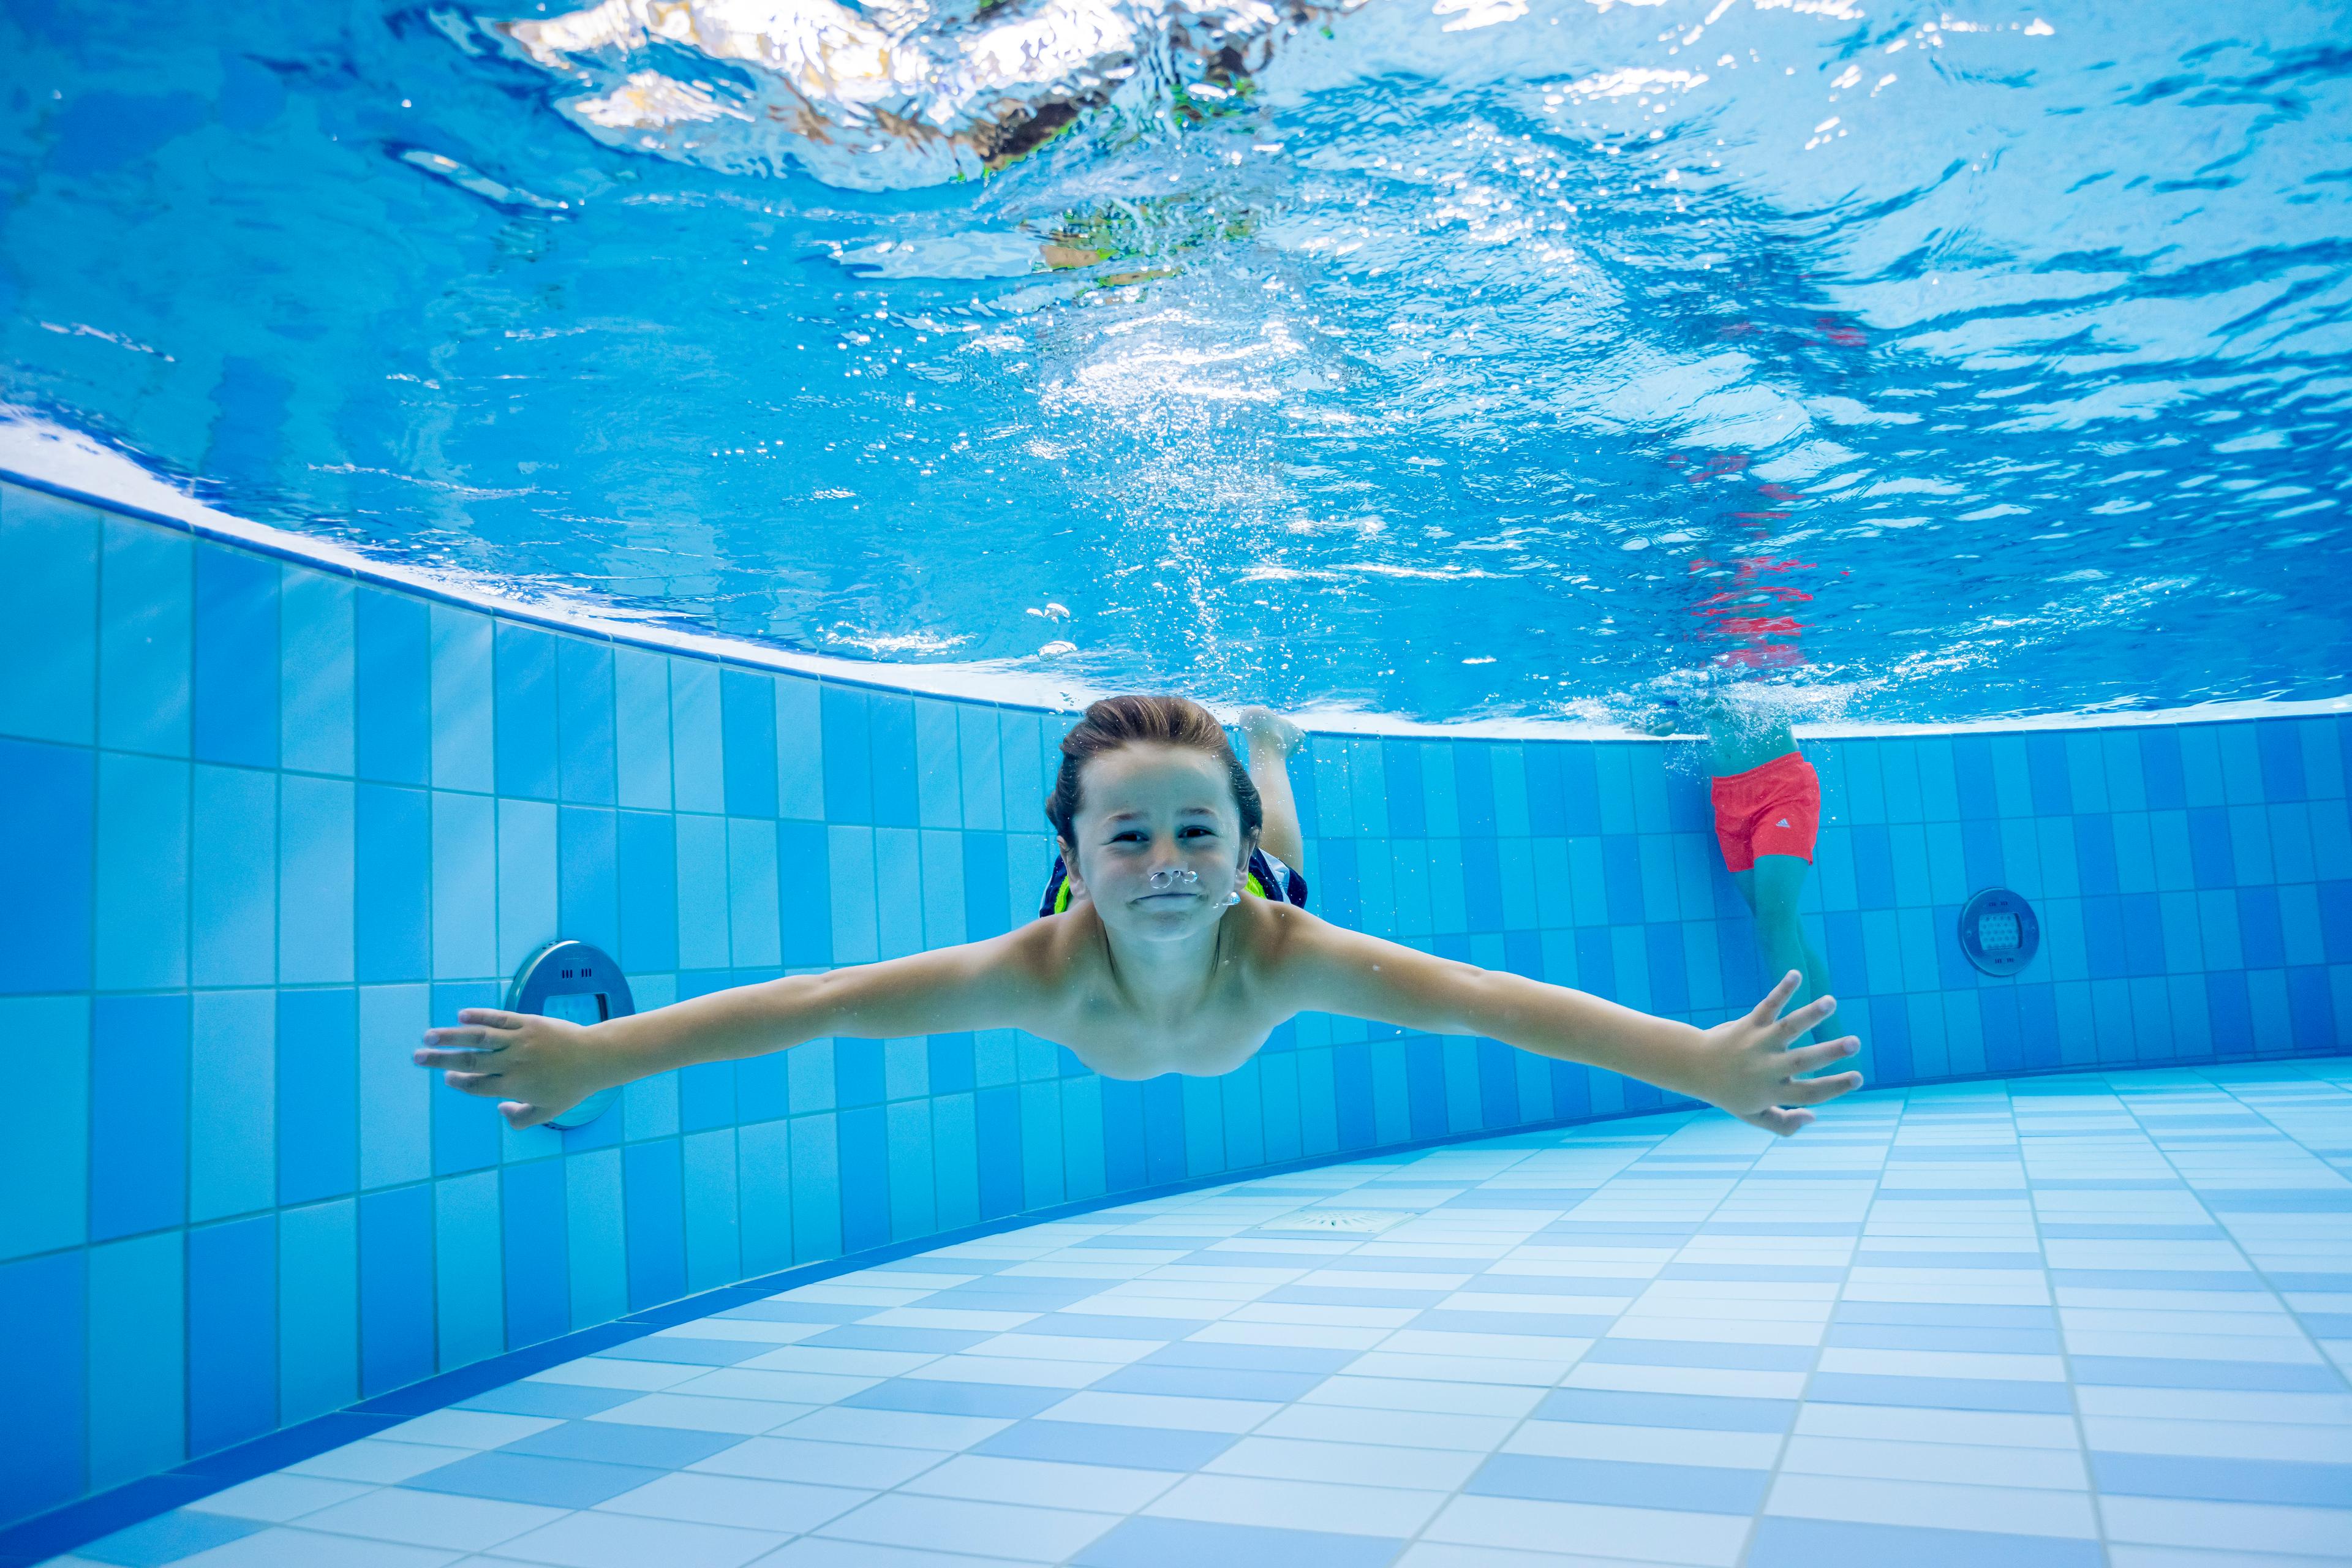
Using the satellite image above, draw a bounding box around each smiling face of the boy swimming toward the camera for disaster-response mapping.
[1061,745,1251,940]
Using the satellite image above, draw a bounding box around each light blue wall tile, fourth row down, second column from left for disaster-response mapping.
[89,1229,188,1490]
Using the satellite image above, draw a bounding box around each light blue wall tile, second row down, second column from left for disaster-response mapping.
[92,752,188,990]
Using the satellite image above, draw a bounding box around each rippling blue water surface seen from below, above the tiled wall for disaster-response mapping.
[0,0,2352,719]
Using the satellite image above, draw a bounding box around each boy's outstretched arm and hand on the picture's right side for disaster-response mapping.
[1296,922,1863,1136]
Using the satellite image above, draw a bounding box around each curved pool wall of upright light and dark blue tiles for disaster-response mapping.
[0,484,2352,1521]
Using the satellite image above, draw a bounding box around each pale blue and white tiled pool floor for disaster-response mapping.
[56,1058,2352,1568]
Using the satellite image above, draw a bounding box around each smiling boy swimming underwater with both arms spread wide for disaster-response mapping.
[417,696,1863,1136]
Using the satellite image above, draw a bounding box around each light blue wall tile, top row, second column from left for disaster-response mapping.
[99,517,195,757]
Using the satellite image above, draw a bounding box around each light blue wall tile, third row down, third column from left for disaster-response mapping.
[188,990,277,1223]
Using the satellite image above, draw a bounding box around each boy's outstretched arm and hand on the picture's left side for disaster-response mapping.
[414,931,1035,1126]
